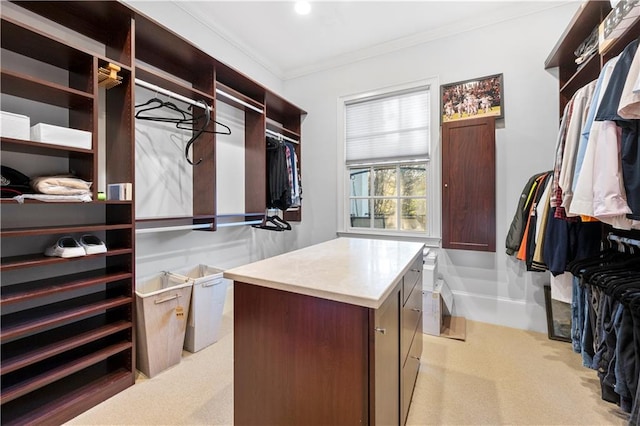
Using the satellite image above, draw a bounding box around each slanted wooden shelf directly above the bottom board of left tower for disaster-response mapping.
[2,342,132,404]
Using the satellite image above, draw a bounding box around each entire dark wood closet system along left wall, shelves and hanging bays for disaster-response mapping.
[0,1,306,425]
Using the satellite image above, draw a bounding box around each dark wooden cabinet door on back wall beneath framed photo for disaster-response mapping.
[442,117,496,252]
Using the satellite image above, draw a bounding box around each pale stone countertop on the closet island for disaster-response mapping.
[224,238,424,309]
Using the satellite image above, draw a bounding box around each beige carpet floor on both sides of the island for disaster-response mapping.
[68,290,627,425]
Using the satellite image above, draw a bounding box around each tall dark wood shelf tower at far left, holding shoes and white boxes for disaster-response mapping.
[0,2,135,425]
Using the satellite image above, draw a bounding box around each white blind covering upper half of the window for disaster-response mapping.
[345,86,430,164]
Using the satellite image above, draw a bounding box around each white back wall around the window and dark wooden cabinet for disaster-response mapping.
[285,3,578,332]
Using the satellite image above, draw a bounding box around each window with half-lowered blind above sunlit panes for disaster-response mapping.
[344,86,431,235]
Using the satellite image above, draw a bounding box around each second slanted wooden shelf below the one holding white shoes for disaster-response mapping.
[0,293,132,342]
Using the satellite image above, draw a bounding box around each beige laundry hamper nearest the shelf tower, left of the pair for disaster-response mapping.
[136,273,193,377]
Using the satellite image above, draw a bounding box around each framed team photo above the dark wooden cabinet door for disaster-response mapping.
[440,74,504,123]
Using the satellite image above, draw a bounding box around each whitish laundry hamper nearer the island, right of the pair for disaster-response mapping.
[170,265,229,352]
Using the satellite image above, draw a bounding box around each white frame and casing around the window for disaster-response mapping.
[337,77,441,243]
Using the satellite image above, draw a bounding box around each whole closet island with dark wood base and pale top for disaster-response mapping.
[224,238,424,425]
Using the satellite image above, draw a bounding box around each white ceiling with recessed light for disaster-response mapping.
[169,0,575,80]
